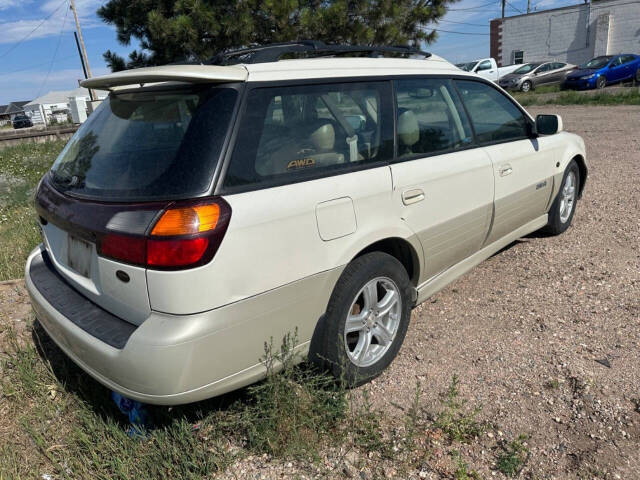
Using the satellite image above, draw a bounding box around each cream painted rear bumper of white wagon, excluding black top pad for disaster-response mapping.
[25,247,341,405]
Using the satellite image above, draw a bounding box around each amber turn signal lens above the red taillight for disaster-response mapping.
[151,203,220,236]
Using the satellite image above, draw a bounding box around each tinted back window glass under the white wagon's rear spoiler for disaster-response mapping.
[51,87,238,201]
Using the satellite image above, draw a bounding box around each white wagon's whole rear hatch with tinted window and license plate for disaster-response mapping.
[36,85,238,324]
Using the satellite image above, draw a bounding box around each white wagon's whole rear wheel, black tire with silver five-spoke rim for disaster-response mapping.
[309,252,413,387]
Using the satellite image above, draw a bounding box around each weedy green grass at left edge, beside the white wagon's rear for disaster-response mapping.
[0,140,66,281]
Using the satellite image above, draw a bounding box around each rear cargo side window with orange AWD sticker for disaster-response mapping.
[224,82,393,191]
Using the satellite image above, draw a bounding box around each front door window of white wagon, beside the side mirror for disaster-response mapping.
[455,80,528,143]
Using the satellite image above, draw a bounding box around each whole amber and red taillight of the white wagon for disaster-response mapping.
[98,198,231,270]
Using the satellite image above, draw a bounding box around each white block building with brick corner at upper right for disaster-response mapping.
[490,0,640,65]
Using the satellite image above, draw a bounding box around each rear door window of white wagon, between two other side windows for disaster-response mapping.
[395,79,472,157]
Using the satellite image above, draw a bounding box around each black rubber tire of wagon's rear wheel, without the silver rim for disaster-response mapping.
[323,252,413,386]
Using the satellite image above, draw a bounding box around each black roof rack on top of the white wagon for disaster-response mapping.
[206,40,431,65]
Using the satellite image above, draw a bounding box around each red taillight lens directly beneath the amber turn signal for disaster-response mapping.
[147,238,209,267]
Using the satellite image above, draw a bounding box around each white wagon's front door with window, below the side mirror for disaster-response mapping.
[456,80,558,243]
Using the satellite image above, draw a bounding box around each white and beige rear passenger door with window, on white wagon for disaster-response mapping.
[391,78,494,282]
